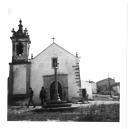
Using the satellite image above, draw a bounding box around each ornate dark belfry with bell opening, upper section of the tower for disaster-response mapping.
[10,19,31,63]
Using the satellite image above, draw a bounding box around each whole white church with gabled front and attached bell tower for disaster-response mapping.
[8,20,81,105]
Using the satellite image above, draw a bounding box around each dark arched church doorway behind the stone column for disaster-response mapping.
[50,81,62,101]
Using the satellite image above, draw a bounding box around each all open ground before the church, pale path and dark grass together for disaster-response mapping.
[7,101,119,122]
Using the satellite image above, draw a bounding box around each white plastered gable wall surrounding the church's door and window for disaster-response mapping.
[31,44,79,102]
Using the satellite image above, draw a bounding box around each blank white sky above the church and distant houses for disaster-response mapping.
[7,0,125,82]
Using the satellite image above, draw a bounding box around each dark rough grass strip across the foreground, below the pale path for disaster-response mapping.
[8,104,119,122]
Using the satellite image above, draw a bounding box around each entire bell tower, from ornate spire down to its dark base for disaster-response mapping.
[8,20,31,103]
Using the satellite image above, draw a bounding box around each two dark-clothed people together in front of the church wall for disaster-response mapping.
[27,86,46,108]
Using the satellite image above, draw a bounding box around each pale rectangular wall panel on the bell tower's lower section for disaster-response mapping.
[13,65,26,94]
